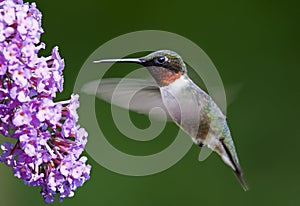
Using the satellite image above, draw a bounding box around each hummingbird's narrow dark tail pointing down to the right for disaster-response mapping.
[221,141,249,191]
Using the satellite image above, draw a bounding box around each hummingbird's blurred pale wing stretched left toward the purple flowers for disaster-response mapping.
[82,78,171,120]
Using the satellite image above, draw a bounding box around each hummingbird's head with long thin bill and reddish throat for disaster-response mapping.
[94,50,186,86]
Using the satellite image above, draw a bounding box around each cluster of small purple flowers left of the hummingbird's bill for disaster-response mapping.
[0,0,91,203]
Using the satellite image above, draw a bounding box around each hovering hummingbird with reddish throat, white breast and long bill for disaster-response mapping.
[88,50,248,191]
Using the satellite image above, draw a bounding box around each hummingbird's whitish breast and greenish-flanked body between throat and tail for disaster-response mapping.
[160,75,225,144]
